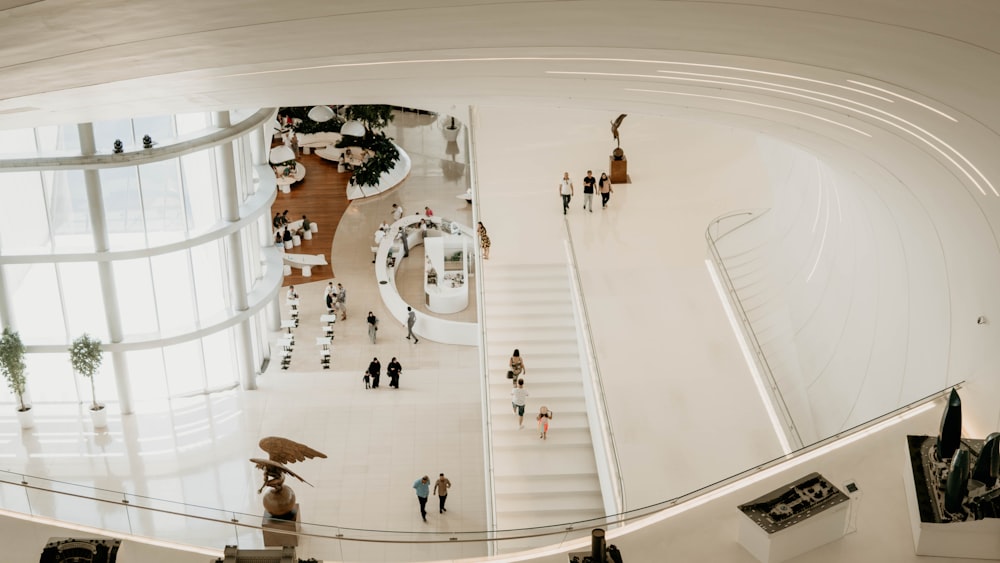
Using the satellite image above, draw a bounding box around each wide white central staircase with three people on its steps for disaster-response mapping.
[483,264,604,552]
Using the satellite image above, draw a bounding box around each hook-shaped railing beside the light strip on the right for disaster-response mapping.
[705,209,804,451]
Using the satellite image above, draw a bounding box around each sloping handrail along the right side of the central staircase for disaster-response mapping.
[563,221,628,523]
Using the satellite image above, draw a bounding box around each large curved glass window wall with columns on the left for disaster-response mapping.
[0,110,281,405]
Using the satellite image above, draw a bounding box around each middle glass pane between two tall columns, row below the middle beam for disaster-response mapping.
[150,250,195,334]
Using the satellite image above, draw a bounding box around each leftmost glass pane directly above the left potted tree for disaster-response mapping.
[4,264,66,344]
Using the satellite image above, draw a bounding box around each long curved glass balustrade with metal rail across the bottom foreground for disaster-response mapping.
[0,381,965,555]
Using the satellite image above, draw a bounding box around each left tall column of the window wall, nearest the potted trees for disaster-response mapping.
[77,123,132,414]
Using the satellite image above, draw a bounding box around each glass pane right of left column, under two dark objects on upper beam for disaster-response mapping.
[101,167,146,250]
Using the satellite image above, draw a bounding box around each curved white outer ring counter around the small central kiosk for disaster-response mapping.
[375,215,478,346]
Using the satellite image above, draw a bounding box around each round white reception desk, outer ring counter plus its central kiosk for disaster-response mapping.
[375,215,478,346]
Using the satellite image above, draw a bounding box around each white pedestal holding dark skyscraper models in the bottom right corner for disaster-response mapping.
[903,448,1000,561]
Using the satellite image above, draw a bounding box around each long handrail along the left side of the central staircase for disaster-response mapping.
[465,105,497,555]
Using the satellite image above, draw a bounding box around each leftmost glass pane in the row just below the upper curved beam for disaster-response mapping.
[0,172,51,254]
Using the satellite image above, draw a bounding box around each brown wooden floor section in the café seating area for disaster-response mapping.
[271,145,351,286]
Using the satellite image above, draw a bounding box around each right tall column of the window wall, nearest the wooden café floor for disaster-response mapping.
[213,111,257,390]
